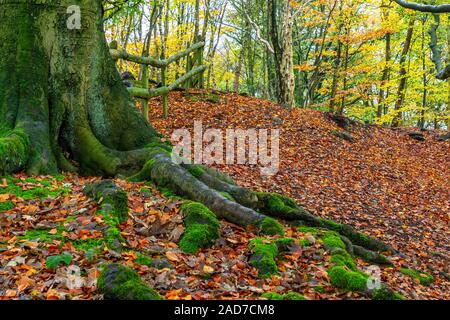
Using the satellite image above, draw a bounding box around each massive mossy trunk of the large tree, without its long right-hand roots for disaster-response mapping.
[0,0,156,175]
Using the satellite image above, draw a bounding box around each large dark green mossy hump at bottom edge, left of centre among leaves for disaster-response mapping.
[97,264,162,300]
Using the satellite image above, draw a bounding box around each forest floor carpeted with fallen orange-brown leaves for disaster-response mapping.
[0,92,450,300]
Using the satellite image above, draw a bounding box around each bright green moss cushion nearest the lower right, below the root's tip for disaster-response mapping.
[328,266,369,292]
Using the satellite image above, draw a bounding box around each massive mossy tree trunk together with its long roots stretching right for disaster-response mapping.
[0,0,392,260]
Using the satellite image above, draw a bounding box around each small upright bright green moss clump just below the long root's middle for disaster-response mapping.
[249,238,278,278]
